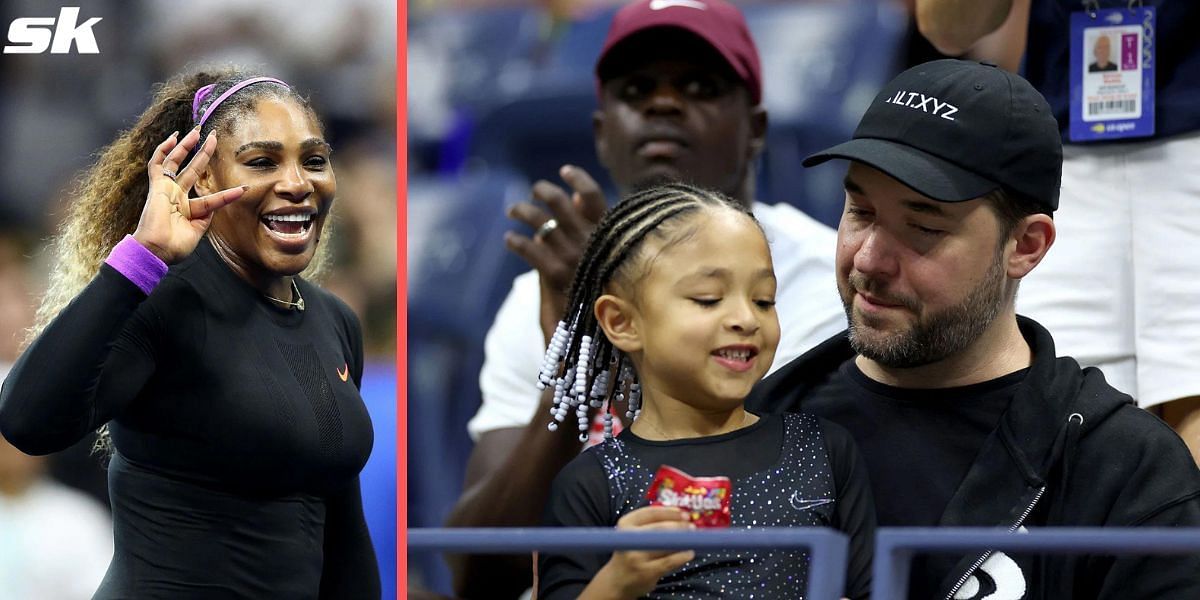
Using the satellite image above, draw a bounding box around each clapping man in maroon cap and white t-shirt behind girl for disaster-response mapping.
[449,0,844,598]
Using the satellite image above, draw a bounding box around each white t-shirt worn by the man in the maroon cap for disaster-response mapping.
[467,203,846,439]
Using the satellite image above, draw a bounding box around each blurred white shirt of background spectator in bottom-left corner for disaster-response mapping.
[0,480,113,600]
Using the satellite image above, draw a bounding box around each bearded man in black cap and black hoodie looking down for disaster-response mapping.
[746,60,1200,600]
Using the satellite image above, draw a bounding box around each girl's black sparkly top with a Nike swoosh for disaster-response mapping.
[538,414,875,600]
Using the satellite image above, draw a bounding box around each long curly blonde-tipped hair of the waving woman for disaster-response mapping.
[32,66,332,449]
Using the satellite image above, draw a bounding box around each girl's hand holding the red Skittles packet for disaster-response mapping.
[581,506,696,599]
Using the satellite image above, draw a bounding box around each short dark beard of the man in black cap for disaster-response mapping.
[842,256,1007,368]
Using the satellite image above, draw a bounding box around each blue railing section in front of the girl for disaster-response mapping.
[408,527,847,600]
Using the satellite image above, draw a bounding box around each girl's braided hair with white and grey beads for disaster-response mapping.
[538,184,754,442]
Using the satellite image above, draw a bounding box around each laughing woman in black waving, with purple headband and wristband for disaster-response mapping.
[0,71,379,599]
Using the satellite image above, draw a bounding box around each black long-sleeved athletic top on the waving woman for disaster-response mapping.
[0,240,379,599]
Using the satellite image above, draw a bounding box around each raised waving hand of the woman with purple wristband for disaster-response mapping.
[133,128,247,264]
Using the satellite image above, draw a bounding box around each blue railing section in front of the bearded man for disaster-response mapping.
[871,527,1200,600]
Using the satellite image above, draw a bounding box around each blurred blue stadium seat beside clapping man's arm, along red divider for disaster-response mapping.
[408,172,529,593]
